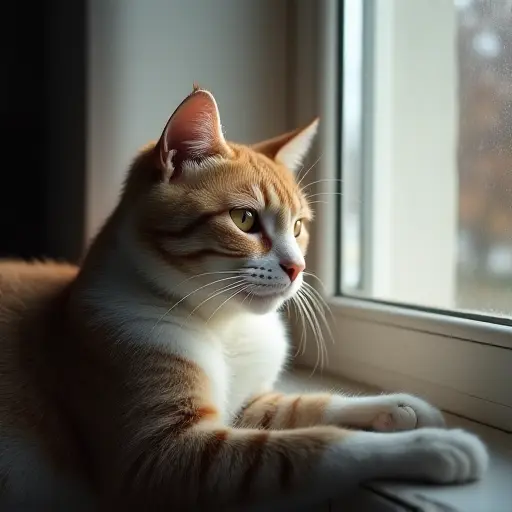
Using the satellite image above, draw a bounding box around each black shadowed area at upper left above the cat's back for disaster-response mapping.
[0,0,86,260]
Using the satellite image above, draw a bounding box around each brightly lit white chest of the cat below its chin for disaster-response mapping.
[223,315,288,416]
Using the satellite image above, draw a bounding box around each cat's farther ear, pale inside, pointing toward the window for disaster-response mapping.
[252,118,319,171]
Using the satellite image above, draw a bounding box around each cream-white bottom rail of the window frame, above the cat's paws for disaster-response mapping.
[295,297,512,432]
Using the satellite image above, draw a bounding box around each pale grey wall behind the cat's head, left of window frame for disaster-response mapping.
[86,0,290,239]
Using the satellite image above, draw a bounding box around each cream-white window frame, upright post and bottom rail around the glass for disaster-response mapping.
[291,0,512,432]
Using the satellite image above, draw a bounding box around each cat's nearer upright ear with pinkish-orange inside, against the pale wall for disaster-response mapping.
[155,86,231,180]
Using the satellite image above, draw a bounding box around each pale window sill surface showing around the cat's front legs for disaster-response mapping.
[278,369,512,512]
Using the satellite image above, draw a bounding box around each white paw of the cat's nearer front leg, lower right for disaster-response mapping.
[403,429,489,484]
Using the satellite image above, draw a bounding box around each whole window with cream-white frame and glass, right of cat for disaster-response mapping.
[296,0,512,431]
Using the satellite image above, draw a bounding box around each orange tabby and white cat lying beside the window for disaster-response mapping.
[0,87,488,511]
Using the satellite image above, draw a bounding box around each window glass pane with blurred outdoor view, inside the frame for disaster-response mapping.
[341,0,512,317]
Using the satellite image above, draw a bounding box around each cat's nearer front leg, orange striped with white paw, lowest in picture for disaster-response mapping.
[117,425,487,510]
